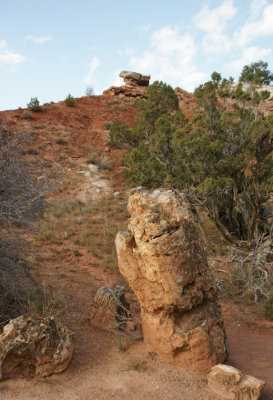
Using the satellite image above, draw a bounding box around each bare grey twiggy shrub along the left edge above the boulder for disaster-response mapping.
[0,127,52,324]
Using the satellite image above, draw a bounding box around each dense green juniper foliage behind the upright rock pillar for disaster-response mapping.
[111,73,273,243]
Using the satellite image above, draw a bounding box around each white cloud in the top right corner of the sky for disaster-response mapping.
[235,1,273,46]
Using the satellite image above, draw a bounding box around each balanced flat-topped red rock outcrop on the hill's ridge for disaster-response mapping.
[103,71,150,98]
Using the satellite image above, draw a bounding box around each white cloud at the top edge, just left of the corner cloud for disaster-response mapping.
[194,0,237,53]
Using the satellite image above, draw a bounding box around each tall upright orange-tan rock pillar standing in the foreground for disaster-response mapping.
[116,188,227,373]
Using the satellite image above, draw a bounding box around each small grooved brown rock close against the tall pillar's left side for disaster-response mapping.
[90,286,133,331]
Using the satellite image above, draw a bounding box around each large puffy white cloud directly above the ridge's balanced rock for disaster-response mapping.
[126,26,207,90]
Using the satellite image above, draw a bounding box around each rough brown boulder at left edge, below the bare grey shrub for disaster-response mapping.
[0,316,74,380]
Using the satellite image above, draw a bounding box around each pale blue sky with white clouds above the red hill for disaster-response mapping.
[0,0,273,110]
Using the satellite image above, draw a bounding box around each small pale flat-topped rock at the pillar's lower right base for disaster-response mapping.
[208,364,265,400]
